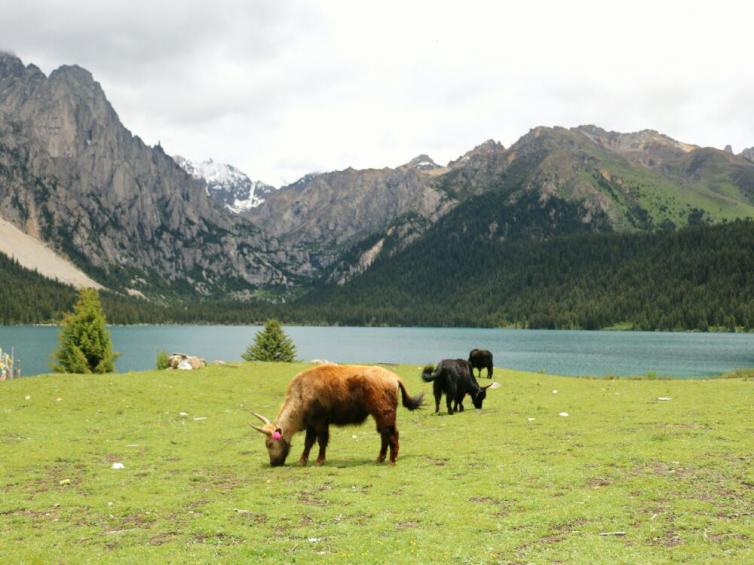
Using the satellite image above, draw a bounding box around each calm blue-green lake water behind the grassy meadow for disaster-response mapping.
[0,326,754,377]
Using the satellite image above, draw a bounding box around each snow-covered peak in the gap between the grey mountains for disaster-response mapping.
[174,155,275,214]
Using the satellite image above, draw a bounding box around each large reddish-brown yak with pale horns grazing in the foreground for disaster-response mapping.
[252,364,424,467]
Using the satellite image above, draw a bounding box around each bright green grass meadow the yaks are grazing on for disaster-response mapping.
[0,363,754,563]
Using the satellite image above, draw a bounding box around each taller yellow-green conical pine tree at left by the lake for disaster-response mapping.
[52,288,119,373]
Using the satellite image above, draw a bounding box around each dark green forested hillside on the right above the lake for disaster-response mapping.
[296,220,754,331]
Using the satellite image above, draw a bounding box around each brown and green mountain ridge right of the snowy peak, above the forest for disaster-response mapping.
[245,121,754,284]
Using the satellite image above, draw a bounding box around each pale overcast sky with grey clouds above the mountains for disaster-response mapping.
[0,0,754,185]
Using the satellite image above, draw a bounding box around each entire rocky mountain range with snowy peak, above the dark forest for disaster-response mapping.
[0,54,754,320]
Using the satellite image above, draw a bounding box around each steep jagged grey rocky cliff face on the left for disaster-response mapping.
[0,54,306,292]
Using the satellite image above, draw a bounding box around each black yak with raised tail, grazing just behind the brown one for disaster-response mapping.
[422,359,500,415]
